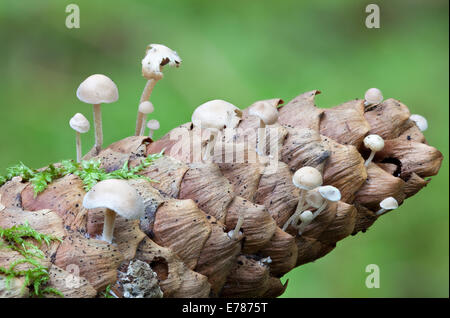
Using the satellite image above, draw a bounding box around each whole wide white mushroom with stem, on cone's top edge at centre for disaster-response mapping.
[192,99,242,161]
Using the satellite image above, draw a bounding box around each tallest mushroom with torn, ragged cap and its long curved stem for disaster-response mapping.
[135,44,181,136]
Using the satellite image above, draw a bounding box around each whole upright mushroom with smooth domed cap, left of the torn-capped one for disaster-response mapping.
[77,74,119,154]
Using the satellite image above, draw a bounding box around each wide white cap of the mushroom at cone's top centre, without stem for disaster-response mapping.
[192,99,242,130]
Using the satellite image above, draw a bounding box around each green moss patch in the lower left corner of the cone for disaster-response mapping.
[0,222,63,297]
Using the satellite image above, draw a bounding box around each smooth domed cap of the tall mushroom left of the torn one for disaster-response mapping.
[77,74,119,104]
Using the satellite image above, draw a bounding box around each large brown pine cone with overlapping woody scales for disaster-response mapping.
[0,91,443,297]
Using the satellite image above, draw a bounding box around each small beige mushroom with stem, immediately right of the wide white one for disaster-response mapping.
[248,101,278,156]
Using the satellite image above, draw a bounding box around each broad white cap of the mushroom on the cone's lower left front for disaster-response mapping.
[83,179,144,219]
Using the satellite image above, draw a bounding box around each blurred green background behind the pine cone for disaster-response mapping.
[0,0,449,297]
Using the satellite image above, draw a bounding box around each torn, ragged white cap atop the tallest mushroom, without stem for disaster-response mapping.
[142,44,181,80]
